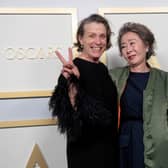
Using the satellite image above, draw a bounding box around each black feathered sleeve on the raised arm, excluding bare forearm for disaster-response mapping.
[49,75,112,136]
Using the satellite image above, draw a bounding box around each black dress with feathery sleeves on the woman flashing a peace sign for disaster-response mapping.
[50,58,117,168]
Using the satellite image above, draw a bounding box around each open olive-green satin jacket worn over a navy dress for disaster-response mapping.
[110,67,168,168]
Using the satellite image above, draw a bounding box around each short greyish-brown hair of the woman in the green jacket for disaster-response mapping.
[118,22,155,59]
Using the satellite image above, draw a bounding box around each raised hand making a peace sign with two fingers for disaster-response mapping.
[55,48,80,79]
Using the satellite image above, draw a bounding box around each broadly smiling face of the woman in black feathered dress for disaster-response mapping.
[79,22,107,62]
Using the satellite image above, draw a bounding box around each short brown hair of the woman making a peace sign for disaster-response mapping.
[74,14,112,51]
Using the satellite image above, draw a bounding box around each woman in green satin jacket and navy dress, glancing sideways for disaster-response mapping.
[110,22,168,168]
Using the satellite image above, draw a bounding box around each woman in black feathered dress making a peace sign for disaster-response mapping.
[49,14,117,168]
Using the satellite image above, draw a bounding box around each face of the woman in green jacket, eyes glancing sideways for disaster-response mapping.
[121,32,148,67]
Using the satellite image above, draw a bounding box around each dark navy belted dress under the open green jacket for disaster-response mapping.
[120,72,149,168]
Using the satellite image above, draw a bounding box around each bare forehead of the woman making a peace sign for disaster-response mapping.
[84,22,106,34]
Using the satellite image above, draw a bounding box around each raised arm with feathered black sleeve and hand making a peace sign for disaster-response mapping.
[49,48,112,136]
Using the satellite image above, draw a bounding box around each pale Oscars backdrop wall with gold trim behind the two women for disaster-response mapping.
[0,0,168,168]
